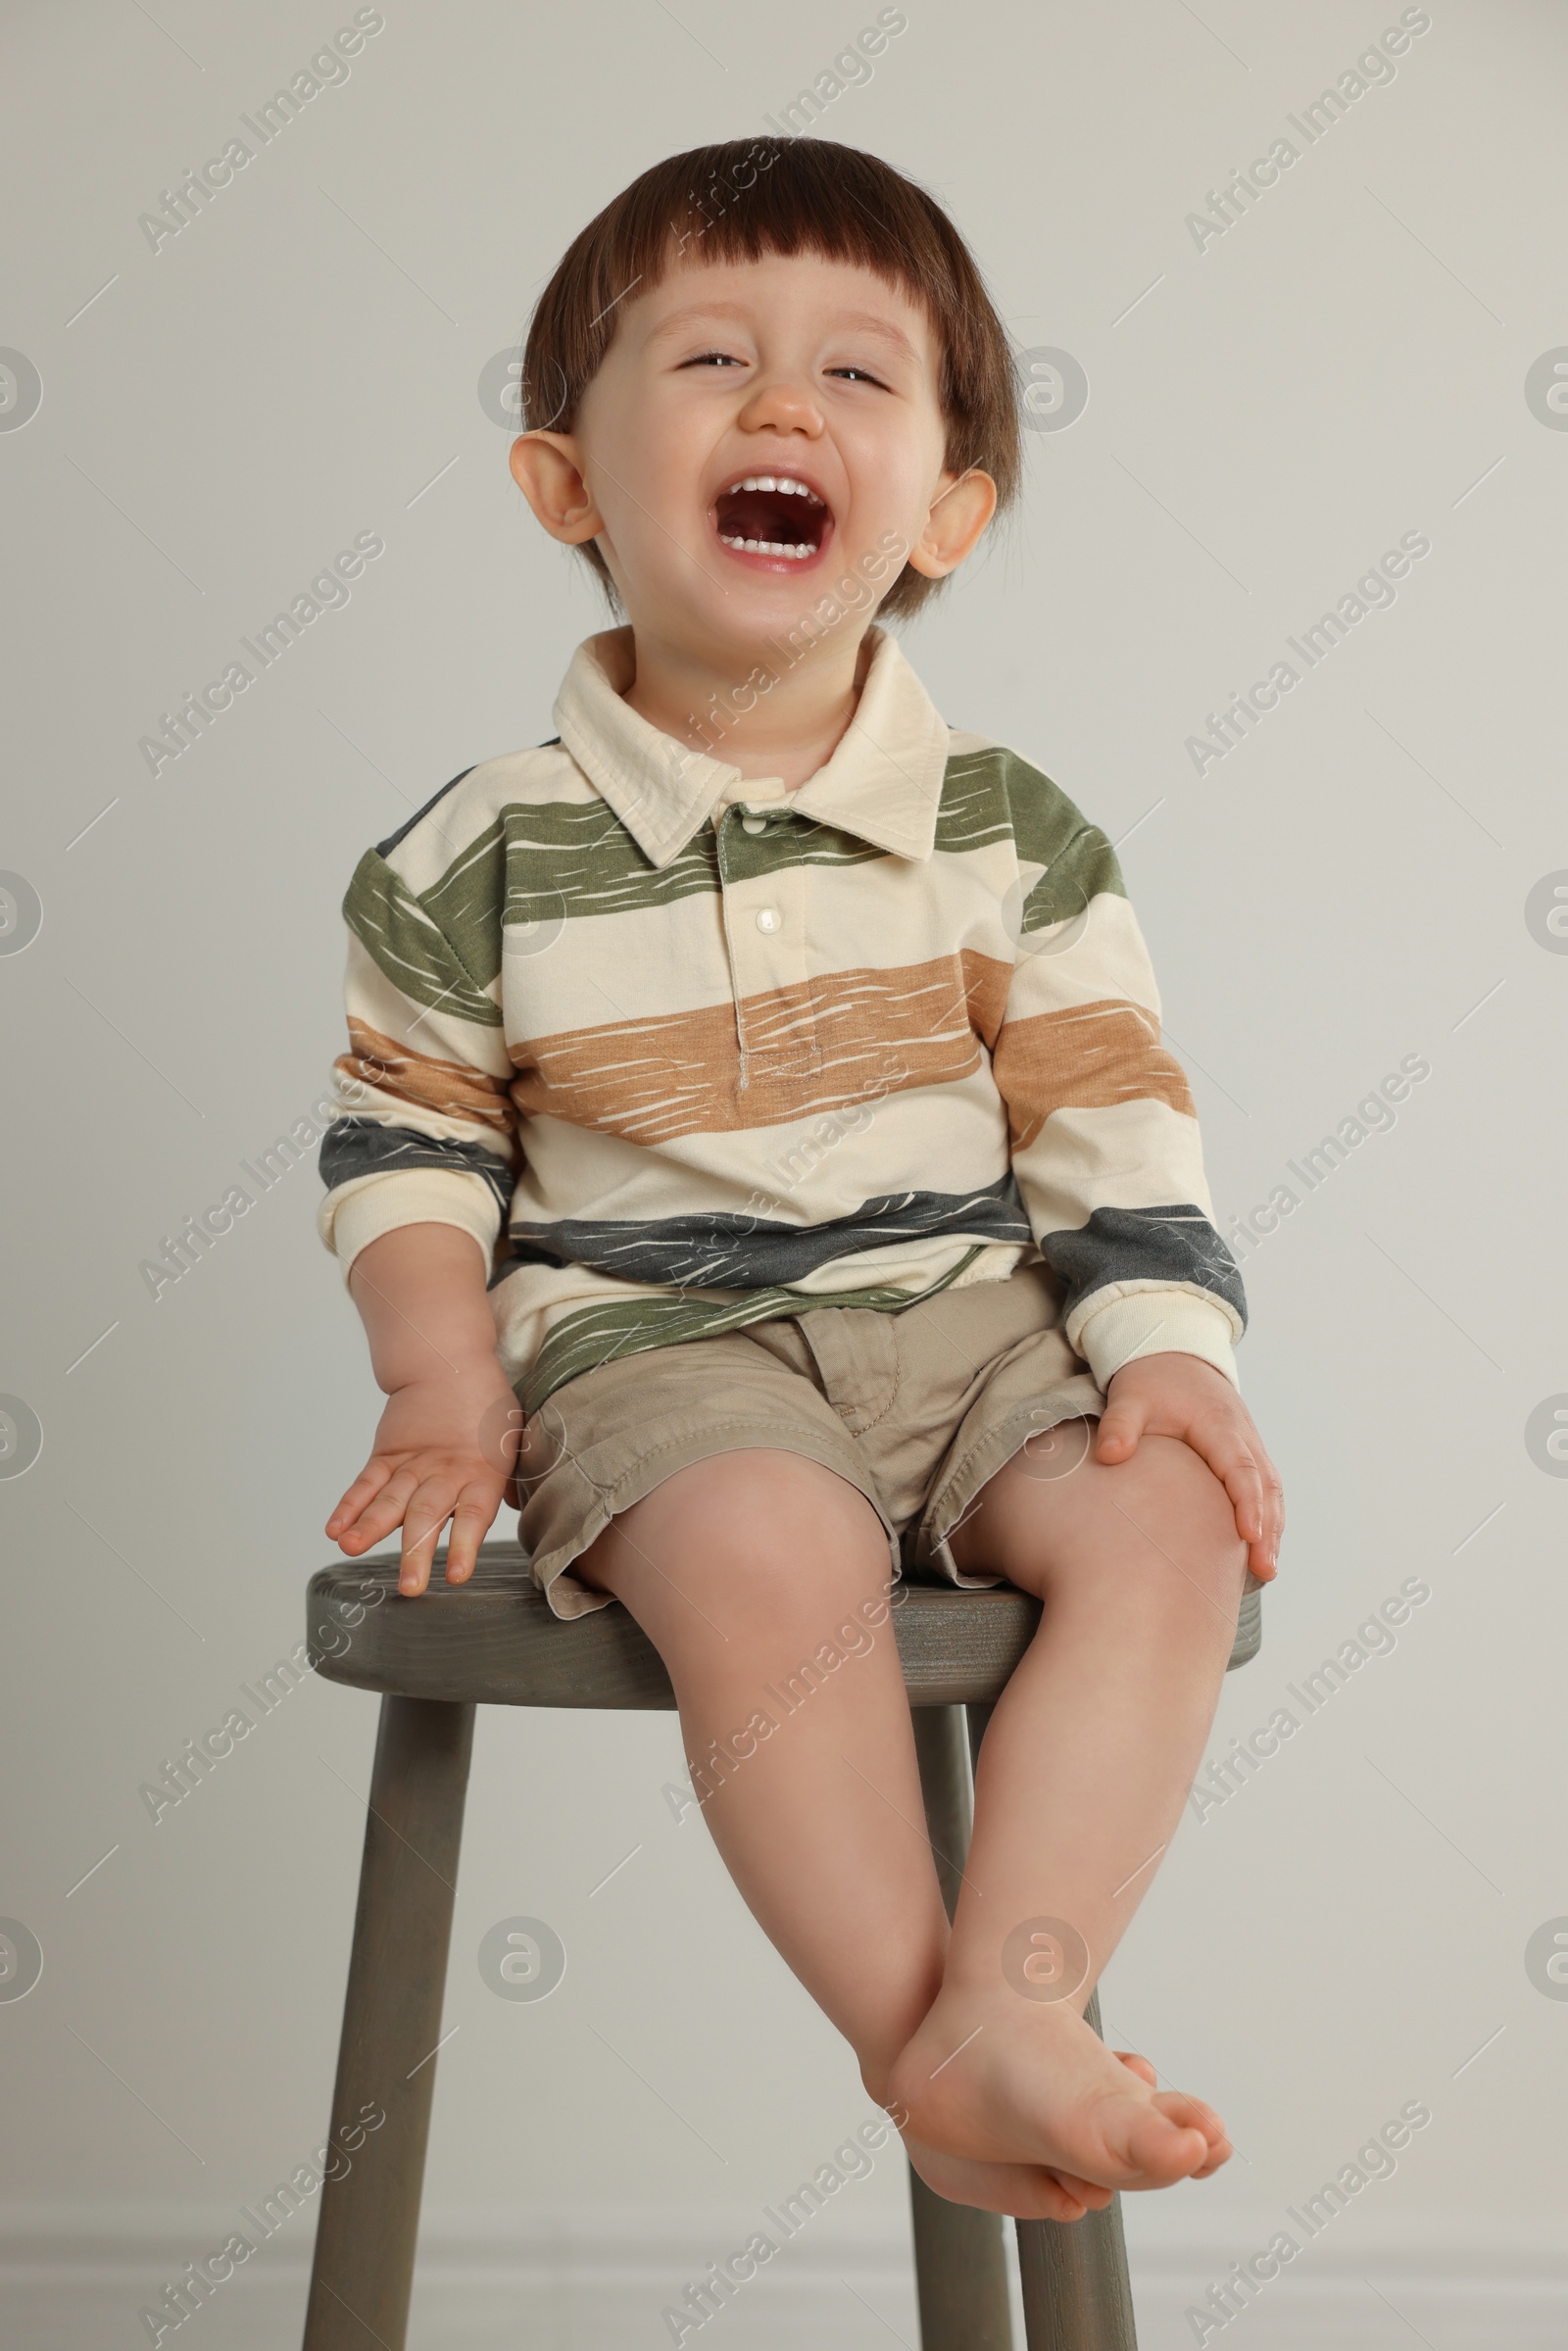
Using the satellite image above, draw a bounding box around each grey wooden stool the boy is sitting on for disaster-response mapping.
[306,1543,1262,2351]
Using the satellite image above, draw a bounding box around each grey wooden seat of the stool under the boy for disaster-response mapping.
[308,1543,1262,1711]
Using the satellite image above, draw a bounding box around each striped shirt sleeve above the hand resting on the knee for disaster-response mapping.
[992,761,1246,1387]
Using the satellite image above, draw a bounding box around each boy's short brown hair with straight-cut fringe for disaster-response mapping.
[522,139,1022,618]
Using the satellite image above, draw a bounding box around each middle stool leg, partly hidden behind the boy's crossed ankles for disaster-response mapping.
[909,1707,1013,2351]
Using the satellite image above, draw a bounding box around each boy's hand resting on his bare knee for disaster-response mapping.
[1093,1354,1286,1585]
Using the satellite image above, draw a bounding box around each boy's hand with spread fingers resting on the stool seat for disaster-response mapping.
[326,1356,522,1594]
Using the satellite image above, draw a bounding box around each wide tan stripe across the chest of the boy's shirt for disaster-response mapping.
[513,955,1008,1143]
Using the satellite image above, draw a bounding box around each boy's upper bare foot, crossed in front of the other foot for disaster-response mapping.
[889,1984,1230,2190]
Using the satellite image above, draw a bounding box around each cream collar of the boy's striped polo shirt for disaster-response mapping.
[555,628,948,867]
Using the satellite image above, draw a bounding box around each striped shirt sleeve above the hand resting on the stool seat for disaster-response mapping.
[318,832,522,1281]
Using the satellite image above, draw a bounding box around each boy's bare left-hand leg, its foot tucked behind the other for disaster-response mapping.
[573,1448,1107,2220]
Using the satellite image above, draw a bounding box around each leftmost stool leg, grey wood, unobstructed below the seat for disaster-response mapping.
[306,1697,475,2351]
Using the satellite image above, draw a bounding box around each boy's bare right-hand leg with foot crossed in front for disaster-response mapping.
[889,1422,1246,2188]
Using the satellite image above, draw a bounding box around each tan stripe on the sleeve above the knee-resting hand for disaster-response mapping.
[992,997,1197,1152]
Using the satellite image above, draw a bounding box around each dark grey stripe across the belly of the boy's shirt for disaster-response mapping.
[499,1168,1032,1291]
